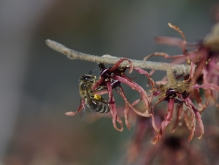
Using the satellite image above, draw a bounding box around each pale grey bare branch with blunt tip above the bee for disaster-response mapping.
[46,39,190,75]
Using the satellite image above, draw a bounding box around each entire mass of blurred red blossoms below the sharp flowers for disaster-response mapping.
[124,114,207,165]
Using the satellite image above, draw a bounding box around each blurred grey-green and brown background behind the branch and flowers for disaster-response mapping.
[0,0,218,165]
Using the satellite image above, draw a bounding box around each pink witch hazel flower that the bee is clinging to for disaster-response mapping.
[92,58,155,131]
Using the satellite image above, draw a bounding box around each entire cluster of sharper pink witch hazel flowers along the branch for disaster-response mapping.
[68,24,219,143]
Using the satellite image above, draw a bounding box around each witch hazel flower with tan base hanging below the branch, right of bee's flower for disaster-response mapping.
[151,69,204,144]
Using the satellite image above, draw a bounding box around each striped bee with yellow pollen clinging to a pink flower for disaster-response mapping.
[79,74,110,113]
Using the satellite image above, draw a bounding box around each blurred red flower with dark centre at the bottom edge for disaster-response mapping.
[139,135,208,165]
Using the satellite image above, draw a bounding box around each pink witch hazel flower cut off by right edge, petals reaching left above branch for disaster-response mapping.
[149,23,219,111]
